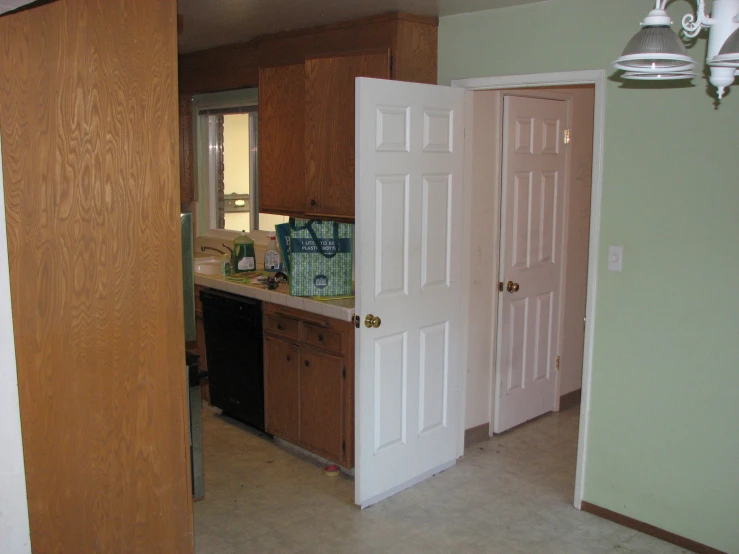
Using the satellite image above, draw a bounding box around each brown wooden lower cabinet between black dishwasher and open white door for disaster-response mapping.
[263,303,354,468]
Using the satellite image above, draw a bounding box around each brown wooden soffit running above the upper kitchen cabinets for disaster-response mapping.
[179,13,439,94]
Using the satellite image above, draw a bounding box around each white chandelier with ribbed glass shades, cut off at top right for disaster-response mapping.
[613,0,739,101]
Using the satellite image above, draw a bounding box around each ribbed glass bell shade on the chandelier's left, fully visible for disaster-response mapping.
[613,25,695,74]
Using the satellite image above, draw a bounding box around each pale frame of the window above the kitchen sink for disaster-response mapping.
[192,88,269,241]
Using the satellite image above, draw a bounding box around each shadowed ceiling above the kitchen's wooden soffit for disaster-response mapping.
[178,0,547,53]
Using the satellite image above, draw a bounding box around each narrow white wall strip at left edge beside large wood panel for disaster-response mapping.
[0,133,31,554]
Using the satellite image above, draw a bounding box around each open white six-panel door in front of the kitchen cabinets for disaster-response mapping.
[355,78,464,508]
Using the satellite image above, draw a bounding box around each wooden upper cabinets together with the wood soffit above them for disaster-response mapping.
[241,13,438,222]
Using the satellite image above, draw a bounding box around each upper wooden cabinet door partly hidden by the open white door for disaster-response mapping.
[304,50,390,220]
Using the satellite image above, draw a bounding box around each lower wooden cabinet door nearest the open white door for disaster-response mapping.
[300,348,344,462]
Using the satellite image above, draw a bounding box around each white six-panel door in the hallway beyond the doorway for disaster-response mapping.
[494,96,567,433]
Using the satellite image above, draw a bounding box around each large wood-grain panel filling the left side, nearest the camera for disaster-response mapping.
[0,0,193,553]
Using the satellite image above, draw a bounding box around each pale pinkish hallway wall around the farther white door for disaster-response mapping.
[465,86,595,429]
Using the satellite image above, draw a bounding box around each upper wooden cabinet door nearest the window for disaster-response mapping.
[258,63,305,215]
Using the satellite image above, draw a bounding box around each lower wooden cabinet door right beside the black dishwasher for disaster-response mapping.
[264,337,300,444]
